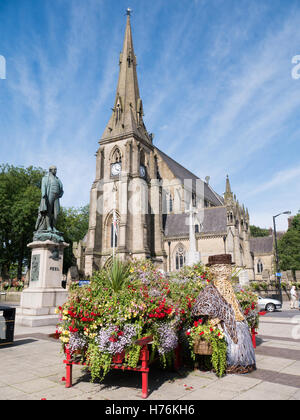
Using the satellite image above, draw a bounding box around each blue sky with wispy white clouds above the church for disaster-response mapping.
[0,0,300,229]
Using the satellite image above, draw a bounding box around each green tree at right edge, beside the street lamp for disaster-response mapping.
[278,212,300,272]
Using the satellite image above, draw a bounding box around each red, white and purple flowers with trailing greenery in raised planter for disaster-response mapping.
[57,260,256,380]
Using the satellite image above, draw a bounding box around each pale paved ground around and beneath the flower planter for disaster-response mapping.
[0,302,300,401]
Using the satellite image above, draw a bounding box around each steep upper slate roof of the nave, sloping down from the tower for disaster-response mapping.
[156,147,224,206]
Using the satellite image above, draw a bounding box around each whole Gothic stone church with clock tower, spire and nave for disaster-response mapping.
[74,11,254,281]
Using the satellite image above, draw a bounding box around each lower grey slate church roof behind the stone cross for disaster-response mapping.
[164,207,227,237]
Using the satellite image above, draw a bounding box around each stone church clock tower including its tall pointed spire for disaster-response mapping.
[85,13,165,275]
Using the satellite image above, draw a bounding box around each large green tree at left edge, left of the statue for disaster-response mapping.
[0,164,46,279]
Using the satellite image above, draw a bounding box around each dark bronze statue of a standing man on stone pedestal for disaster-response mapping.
[35,166,64,232]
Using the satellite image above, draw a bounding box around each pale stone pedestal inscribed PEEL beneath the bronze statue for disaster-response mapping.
[16,240,69,327]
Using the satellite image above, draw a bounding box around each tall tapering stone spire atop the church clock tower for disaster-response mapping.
[102,9,151,142]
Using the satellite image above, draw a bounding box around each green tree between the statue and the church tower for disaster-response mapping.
[56,205,89,273]
